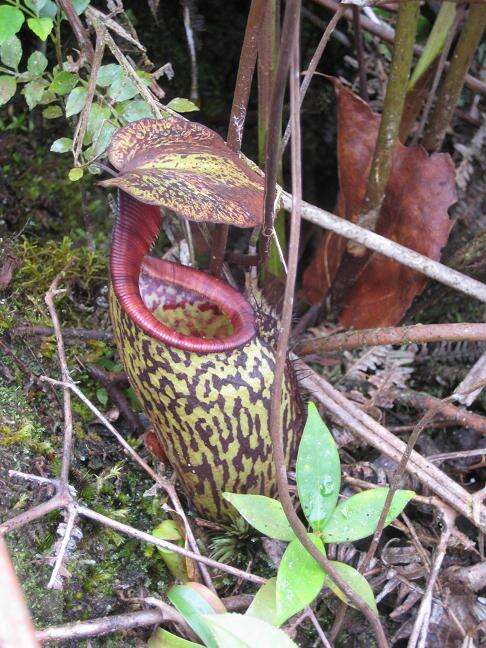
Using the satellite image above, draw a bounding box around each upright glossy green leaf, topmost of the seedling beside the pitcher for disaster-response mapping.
[296,403,341,531]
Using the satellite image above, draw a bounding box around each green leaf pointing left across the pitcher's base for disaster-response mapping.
[223,493,295,541]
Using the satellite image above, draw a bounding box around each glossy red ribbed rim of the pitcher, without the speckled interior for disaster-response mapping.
[110,191,255,353]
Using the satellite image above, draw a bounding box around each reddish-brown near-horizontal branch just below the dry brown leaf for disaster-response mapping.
[296,323,486,355]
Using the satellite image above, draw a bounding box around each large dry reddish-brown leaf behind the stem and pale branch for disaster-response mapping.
[303,80,456,328]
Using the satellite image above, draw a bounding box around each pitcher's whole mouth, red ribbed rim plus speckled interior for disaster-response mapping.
[110,192,255,353]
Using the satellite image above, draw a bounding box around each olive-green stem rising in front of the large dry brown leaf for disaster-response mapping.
[359,0,419,230]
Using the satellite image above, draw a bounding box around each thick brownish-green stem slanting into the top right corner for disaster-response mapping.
[422,4,486,151]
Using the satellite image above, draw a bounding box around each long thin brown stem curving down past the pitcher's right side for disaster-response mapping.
[267,22,388,648]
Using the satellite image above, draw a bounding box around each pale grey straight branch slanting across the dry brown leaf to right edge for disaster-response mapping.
[281,192,486,302]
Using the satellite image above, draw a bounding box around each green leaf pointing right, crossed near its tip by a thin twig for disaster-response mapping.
[323,488,415,542]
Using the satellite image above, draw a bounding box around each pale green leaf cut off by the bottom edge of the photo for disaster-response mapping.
[199,613,297,648]
